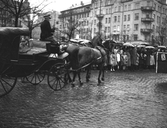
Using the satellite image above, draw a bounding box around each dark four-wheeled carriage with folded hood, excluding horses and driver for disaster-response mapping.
[0,27,68,97]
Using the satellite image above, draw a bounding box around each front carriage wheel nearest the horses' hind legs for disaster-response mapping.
[47,63,68,91]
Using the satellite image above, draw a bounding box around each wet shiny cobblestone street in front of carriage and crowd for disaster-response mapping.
[0,70,167,128]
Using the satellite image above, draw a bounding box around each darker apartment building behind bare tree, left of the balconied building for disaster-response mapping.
[59,2,93,39]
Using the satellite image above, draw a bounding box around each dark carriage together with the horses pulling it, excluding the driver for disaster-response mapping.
[0,27,113,97]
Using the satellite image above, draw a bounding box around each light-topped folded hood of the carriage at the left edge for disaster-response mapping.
[0,27,30,36]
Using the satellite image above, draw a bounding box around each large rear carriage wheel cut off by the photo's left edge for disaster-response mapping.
[0,75,17,97]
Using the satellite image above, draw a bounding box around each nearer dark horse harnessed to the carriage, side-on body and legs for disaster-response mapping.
[62,40,107,86]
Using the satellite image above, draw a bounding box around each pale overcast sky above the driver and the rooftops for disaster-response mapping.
[29,0,91,11]
